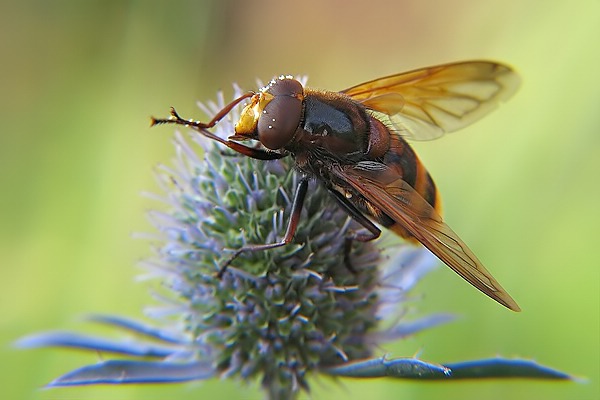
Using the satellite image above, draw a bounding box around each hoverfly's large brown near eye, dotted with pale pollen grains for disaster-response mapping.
[257,94,302,150]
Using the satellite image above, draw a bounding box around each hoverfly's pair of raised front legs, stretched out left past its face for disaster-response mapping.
[150,108,287,160]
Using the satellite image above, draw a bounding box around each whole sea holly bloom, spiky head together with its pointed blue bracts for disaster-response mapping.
[19,80,568,399]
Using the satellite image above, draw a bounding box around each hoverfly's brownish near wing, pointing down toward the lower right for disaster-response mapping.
[334,163,520,311]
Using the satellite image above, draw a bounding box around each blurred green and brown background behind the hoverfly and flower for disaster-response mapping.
[0,0,600,400]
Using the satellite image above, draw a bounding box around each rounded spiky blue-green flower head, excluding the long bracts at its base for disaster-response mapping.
[146,79,431,397]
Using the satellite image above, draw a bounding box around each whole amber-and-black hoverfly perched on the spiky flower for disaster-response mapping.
[152,61,520,311]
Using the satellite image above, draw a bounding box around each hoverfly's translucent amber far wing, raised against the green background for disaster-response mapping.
[342,61,520,140]
